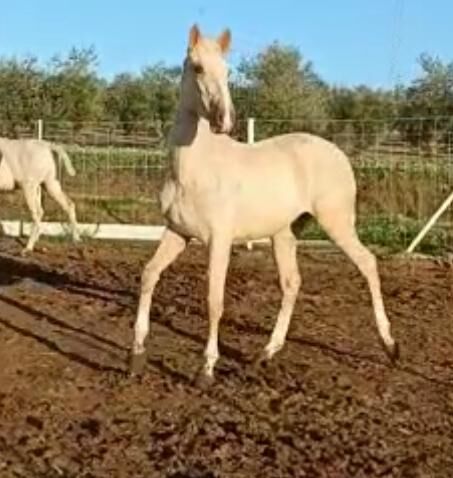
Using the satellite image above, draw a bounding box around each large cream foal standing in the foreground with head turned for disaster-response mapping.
[131,25,398,384]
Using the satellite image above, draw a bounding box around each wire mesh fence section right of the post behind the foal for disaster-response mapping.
[255,117,453,251]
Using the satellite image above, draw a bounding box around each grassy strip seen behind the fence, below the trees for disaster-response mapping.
[0,147,453,253]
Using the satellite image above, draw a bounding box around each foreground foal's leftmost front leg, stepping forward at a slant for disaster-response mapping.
[130,229,187,374]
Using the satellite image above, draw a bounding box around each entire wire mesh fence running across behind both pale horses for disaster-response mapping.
[0,118,453,250]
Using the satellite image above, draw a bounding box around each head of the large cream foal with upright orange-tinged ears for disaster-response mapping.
[182,25,234,133]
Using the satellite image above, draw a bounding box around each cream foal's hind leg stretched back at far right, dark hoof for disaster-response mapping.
[316,205,399,360]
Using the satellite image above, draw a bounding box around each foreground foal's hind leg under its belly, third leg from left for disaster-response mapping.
[265,228,301,358]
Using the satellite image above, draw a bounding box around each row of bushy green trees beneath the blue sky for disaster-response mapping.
[0,42,453,146]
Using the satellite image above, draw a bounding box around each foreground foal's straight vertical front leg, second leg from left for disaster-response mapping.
[199,236,231,384]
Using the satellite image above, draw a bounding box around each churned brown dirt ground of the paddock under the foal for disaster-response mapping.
[0,239,453,478]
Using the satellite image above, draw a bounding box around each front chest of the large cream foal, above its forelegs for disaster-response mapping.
[160,180,207,240]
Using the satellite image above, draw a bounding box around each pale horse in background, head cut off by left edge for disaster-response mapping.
[0,138,80,254]
